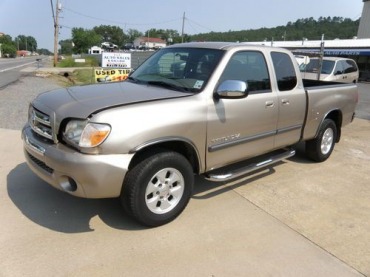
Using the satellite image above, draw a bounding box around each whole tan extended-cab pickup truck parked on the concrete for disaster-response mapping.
[22,42,358,226]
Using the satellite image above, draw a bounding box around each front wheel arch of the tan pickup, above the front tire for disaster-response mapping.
[129,137,202,173]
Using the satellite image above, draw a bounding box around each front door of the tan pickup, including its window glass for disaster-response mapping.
[206,51,279,171]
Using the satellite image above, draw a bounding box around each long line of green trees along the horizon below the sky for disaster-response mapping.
[0,16,360,56]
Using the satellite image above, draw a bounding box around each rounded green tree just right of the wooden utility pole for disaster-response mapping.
[72,28,101,54]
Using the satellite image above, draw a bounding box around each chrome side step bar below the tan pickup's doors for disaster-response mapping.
[205,149,295,182]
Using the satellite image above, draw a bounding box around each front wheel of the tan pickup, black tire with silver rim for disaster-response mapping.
[121,151,194,227]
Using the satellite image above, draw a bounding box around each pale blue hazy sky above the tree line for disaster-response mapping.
[0,0,363,51]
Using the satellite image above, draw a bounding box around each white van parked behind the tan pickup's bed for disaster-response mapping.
[300,57,359,83]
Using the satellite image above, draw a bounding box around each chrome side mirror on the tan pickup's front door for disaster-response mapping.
[215,80,248,99]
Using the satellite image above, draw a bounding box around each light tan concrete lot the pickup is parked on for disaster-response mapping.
[0,68,370,276]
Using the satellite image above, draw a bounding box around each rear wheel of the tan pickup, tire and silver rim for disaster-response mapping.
[306,119,338,162]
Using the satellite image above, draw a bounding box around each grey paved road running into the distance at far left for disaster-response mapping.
[0,56,45,88]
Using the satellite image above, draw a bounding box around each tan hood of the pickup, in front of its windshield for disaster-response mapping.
[33,81,193,118]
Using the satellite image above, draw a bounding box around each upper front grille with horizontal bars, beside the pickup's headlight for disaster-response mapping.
[29,108,53,141]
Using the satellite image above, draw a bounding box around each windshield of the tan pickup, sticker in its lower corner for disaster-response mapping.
[129,48,224,92]
